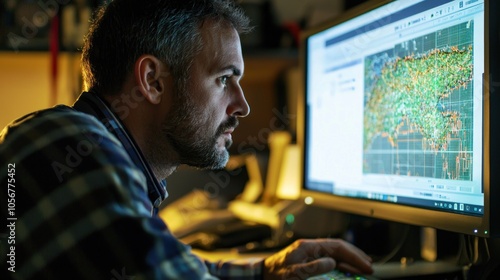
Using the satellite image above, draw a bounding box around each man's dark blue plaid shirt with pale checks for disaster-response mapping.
[0,93,262,280]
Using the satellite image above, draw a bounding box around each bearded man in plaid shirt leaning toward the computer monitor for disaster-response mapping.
[0,0,371,279]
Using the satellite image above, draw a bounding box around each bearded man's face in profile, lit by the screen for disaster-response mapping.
[162,22,250,169]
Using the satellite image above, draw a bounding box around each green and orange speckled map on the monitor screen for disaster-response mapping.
[363,21,474,181]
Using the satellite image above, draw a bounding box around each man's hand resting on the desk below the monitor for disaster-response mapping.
[264,239,373,280]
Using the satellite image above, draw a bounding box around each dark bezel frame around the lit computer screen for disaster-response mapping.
[297,0,500,237]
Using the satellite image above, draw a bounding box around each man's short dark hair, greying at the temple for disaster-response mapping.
[82,0,251,94]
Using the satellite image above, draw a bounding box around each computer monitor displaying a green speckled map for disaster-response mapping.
[301,0,500,237]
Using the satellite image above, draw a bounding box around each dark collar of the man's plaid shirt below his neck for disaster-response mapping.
[73,92,168,208]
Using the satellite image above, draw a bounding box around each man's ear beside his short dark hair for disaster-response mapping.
[134,54,169,104]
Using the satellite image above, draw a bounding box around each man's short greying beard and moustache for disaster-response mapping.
[162,92,238,169]
